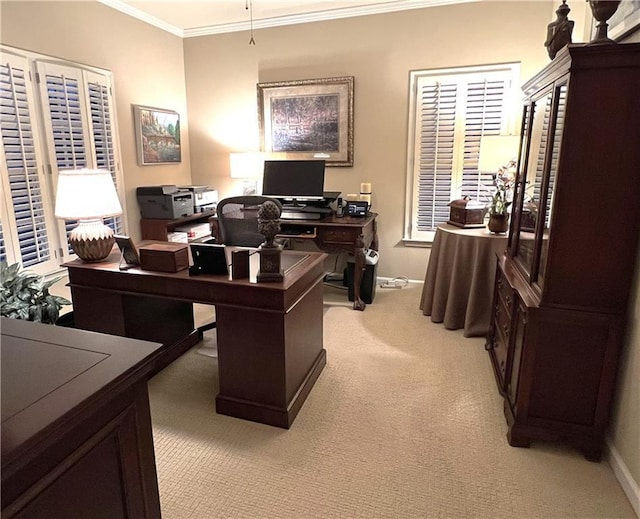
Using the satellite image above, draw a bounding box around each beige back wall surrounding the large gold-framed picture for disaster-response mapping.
[184,2,551,280]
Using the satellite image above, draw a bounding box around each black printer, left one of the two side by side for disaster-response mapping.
[136,185,194,220]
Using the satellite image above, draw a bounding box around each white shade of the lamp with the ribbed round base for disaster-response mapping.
[55,168,122,220]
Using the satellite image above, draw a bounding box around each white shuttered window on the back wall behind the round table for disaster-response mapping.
[404,63,520,244]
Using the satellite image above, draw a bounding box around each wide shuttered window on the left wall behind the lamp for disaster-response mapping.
[0,47,124,274]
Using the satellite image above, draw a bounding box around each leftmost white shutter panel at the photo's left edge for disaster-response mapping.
[0,53,57,273]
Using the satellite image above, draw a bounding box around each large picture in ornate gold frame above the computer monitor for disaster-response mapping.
[258,76,354,167]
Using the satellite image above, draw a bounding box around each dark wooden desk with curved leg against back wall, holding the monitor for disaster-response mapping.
[209,213,378,310]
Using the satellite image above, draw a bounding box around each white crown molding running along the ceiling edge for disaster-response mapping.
[98,0,482,38]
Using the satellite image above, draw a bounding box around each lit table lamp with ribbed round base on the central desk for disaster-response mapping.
[55,168,122,262]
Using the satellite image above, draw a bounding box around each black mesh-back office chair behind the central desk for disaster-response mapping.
[198,195,282,333]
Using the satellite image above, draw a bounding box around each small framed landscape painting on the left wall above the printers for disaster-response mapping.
[133,105,181,166]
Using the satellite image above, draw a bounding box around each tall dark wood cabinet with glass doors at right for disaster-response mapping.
[487,44,640,460]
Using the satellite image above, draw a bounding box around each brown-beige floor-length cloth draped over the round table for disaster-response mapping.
[420,224,507,337]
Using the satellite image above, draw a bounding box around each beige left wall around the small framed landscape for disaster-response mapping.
[0,2,191,241]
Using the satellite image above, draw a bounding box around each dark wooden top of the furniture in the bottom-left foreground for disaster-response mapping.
[0,317,162,465]
